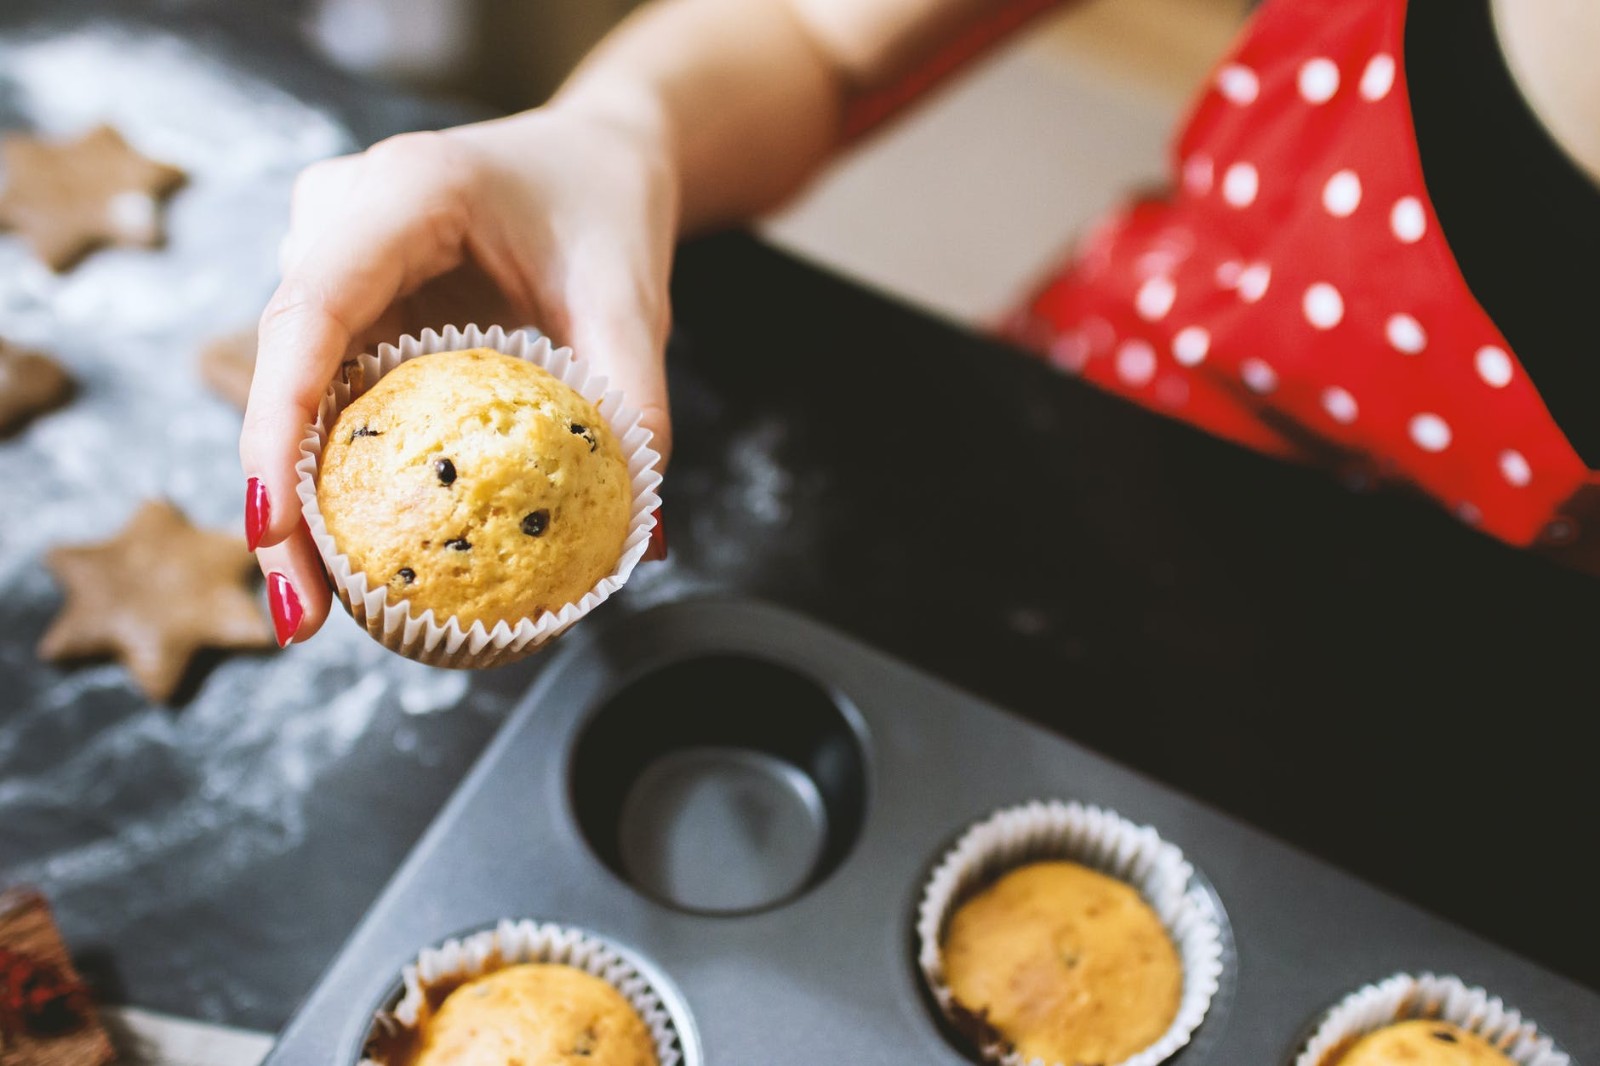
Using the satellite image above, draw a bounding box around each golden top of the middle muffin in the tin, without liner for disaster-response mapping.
[941,863,1184,1066]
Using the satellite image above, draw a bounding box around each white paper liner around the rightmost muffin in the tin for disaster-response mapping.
[1294,973,1571,1066]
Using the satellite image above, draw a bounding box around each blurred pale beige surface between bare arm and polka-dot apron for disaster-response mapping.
[763,40,1179,325]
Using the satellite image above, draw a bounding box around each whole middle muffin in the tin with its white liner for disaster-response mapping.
[917,802,1222,1066]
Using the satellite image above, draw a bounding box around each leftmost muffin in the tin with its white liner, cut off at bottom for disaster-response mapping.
[362,920,693,1066]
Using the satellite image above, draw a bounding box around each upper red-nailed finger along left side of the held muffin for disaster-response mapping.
[240,134,469,546]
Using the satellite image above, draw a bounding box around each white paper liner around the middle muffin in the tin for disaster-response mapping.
[917,800,1222,1066]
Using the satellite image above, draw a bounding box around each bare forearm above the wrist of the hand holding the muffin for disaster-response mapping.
[555,0,1046,230]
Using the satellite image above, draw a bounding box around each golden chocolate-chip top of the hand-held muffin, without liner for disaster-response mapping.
[317,347,632,627]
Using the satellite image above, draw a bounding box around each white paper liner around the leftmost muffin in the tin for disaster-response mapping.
[360,919,698,1066]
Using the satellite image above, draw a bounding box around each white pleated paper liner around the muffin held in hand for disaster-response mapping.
[294,325,661,667]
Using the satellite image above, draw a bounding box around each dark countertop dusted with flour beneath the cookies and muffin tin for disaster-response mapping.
[0,5,1600,1028]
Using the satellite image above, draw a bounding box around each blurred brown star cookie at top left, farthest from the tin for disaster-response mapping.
[0,126,184,271]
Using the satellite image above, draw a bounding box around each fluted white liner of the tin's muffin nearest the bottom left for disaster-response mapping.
[360,919,699,1066]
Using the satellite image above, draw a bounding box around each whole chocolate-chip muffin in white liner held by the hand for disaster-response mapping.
[299,328,661,666]
